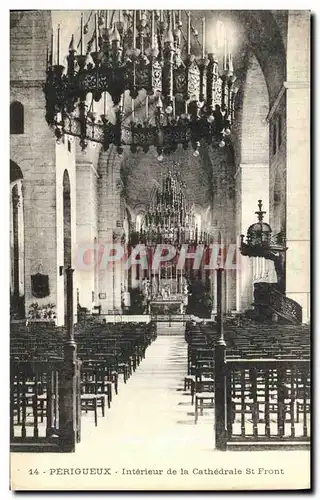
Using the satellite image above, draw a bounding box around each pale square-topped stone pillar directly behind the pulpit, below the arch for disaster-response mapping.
[236,164,269,311]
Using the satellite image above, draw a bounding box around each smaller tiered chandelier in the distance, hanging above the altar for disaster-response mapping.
[131,171,210,248]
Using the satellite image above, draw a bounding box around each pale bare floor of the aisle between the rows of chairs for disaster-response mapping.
[79,335,214,456]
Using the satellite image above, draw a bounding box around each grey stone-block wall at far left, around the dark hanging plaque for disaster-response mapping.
[10,11,57,320]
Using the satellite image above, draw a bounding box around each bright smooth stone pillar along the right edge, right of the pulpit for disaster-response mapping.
[285,11,310,321]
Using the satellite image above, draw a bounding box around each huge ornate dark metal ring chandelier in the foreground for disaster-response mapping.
[44,10,237,156]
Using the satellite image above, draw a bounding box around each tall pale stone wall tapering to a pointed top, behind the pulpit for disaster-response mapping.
[233,54,269,311]
